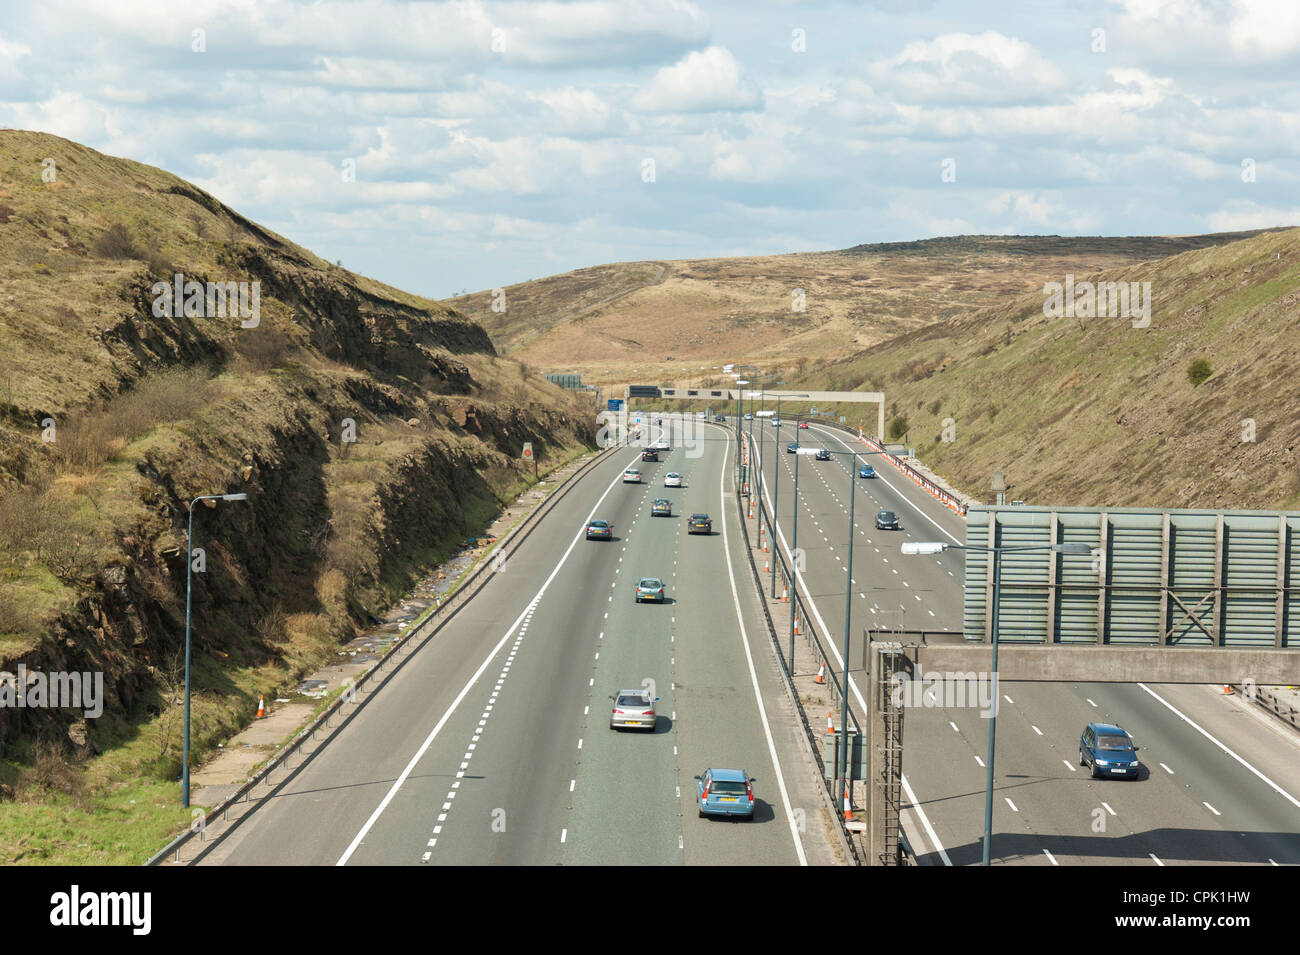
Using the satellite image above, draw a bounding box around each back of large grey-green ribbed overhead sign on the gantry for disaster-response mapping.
[963,505,1300,650]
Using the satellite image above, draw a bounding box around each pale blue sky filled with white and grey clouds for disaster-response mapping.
[0,0,1300,298]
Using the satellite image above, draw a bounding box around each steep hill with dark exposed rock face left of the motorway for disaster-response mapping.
[0,130,593,863]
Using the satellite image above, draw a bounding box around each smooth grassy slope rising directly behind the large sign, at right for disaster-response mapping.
[790,229,1300,508]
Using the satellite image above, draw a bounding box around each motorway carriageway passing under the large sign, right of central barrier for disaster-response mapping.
[745,420,1300,865]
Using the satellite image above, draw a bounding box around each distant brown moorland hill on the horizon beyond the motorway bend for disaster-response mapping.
[449,233,1253,383]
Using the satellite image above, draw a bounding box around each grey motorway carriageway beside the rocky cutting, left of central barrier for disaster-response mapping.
[198,421,846,865]
